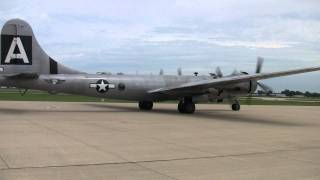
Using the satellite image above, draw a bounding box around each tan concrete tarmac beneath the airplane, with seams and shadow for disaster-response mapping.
[0,101,320,180]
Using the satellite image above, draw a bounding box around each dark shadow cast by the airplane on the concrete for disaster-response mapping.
[0,104,312,126]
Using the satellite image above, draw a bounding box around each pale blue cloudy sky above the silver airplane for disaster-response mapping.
[0,0,320,92]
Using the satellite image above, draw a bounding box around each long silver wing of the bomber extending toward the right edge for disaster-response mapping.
[149,67,320,94]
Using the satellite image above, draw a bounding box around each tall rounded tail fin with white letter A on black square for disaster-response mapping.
[0,19,81,75]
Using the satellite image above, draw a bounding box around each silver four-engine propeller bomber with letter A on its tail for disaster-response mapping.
[0,19,320,114]
